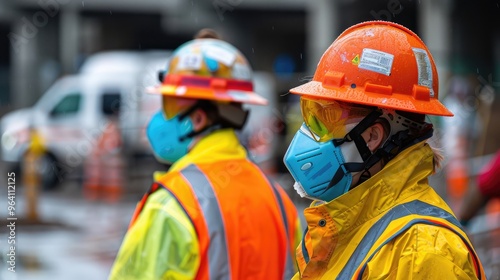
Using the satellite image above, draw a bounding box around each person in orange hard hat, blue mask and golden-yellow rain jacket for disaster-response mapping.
[284,21,485,279]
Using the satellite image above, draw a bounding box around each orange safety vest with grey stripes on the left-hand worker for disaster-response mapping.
[131,159,297,279]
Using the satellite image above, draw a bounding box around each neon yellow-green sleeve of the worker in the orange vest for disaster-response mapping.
[109,189,200,280]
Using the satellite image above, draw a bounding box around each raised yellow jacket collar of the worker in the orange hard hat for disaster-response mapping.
[304,141,434,238]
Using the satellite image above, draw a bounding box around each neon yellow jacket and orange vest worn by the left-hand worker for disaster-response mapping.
[110,129,301,280]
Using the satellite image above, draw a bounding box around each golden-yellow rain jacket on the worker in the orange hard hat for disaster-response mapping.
[293,142,486,280]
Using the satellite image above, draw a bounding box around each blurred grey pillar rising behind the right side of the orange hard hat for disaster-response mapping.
[418,0,452,99]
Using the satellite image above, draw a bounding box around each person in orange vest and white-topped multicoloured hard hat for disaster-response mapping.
[110,29,301,279]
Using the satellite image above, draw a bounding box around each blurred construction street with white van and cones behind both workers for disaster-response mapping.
[0,0,500,279]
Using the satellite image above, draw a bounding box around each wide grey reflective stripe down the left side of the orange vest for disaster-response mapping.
[180,165,231,279]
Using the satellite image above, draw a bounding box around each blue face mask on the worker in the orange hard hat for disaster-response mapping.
[284,124,360,201]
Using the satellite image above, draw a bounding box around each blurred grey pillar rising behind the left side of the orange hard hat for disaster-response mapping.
[306,0,340,75]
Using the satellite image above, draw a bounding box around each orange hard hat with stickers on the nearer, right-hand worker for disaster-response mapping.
[290,21,453,116]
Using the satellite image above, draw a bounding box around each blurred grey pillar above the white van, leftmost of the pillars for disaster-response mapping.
[59,7,81,74]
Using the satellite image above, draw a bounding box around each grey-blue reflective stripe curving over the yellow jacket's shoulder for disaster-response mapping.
[337,200,472,279]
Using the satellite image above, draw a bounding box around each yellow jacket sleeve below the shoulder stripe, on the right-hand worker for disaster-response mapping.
[362,225,484,280]
